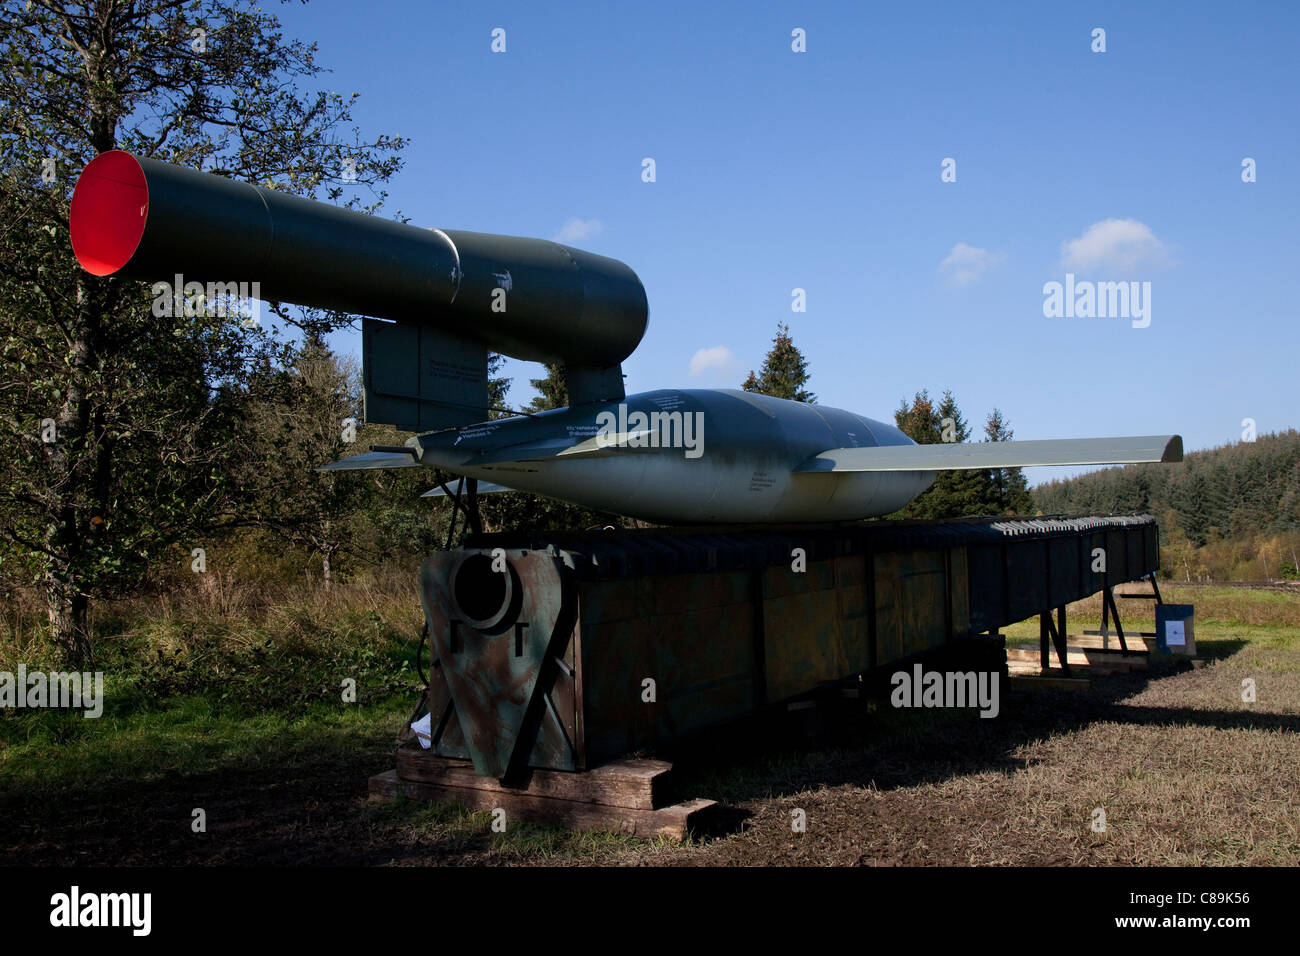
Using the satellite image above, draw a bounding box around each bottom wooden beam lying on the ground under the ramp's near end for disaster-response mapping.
[371,770,716,840]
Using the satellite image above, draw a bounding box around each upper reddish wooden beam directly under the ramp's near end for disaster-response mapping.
[397,747,672,810]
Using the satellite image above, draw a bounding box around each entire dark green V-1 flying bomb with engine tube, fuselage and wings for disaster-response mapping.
[70,151,1183,524]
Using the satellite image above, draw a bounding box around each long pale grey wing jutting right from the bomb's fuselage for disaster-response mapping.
[794,434,1183,473]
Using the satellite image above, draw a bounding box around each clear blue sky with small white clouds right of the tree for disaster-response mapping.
[279,0,1300,481]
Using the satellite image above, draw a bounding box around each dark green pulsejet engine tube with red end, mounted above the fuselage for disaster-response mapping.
[69,150,647,369]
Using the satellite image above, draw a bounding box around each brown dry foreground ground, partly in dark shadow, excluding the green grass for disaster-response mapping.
[0,640,1300,866]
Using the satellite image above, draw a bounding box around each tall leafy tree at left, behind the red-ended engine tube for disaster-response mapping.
[0,0,403,666]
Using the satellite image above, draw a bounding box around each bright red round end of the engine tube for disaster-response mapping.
[68,150,150,276]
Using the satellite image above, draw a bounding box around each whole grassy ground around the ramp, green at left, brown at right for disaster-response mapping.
[0,578,1300,866]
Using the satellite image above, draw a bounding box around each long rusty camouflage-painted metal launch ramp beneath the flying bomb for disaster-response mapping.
[379,515,1158,784]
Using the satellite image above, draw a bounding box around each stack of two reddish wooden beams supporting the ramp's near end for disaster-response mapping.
[371,747,716,840]
